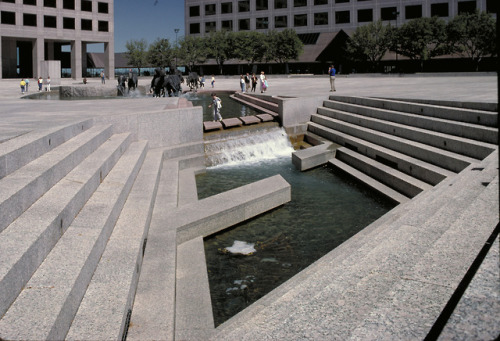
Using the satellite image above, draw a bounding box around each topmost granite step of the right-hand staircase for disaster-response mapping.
[330,96,498,128]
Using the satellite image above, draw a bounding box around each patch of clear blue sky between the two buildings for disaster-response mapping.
[114,0,184,52]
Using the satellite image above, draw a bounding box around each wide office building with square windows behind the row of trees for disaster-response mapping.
[184,0,499,71]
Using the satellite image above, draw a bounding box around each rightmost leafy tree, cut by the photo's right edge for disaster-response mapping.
[446,10,496,71]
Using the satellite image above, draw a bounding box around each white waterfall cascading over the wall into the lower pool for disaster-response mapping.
[205,127,293,167]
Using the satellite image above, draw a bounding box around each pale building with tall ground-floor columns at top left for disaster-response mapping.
[0,0,115,79]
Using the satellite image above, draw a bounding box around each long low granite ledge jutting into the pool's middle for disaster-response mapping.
[177,175,291,245]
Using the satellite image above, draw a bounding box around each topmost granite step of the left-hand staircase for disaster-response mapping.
[0,120,92,179]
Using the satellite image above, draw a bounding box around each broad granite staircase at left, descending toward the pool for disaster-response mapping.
[0,120,176,340]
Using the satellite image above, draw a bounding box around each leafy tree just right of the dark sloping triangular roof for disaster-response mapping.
[347,20,391,71]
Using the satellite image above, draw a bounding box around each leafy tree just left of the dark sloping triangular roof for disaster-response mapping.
[266,28,304,73]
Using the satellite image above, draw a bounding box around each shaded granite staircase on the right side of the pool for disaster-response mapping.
[308,96,498,203]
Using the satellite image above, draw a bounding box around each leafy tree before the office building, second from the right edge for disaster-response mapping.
[391,17,448,71]
